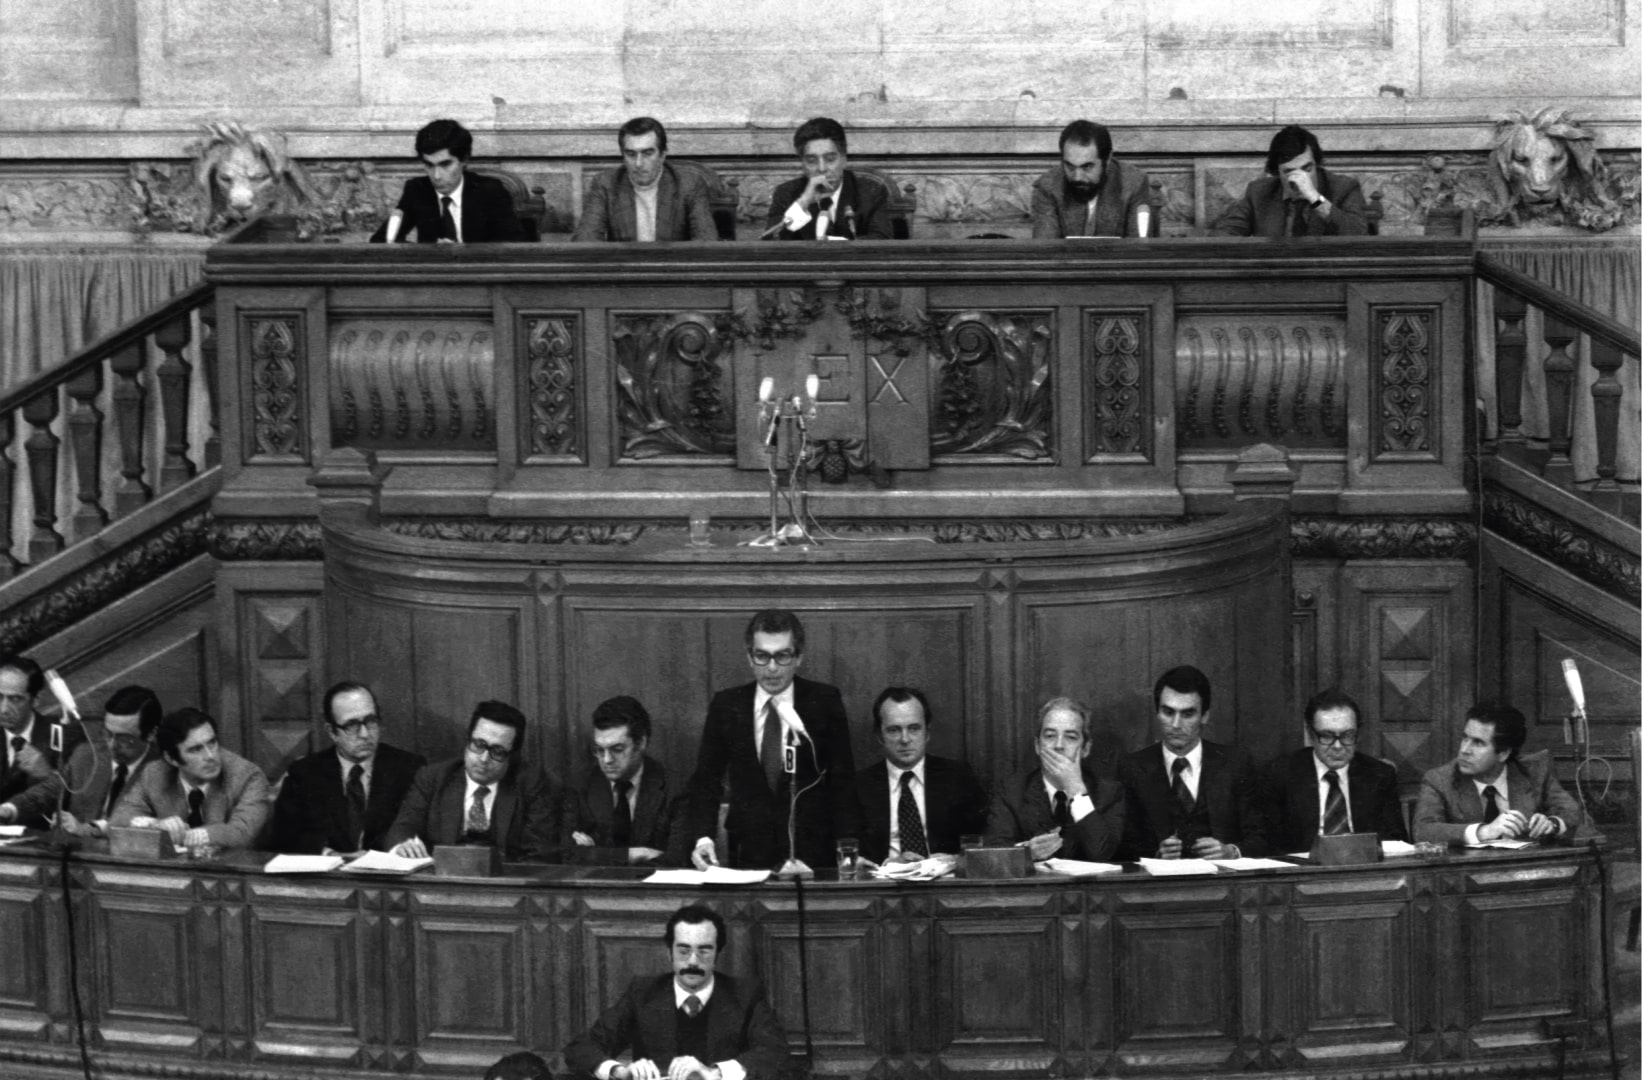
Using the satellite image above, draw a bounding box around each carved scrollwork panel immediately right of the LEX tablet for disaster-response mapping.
[929,312,1054,461]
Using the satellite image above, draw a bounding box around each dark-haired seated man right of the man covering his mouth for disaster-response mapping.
[1118,666,1269,858]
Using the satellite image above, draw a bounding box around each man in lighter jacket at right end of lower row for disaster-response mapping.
[1414,701,1585,844]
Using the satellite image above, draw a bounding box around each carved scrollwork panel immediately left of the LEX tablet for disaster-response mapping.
[611,312,736,460]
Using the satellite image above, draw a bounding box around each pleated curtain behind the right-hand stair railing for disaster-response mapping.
[1476,244,1642,481]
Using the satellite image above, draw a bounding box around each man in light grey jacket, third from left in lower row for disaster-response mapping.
[108,709,269,850]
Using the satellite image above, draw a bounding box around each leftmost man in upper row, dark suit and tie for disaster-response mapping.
[371,120,525,245]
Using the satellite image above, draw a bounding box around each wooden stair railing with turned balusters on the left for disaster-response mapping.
[0,284,220,581]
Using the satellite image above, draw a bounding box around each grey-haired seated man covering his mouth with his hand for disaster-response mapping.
[985,698,1125,862]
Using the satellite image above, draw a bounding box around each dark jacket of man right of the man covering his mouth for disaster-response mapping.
[1118,739,1271,860]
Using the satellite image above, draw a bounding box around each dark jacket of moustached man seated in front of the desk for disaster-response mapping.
[565,972,787,1080]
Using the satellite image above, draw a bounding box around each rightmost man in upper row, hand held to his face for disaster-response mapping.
[1212,123,1368,240]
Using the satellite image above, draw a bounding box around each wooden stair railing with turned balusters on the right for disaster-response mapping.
[1476,251,1642,514]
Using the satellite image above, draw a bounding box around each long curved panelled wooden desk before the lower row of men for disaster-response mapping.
[0,849,1603,1080]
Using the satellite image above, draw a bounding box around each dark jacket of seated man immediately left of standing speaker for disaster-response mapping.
[558,753,695,867]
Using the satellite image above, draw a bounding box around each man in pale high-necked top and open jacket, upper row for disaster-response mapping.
[571,117,718,243]
